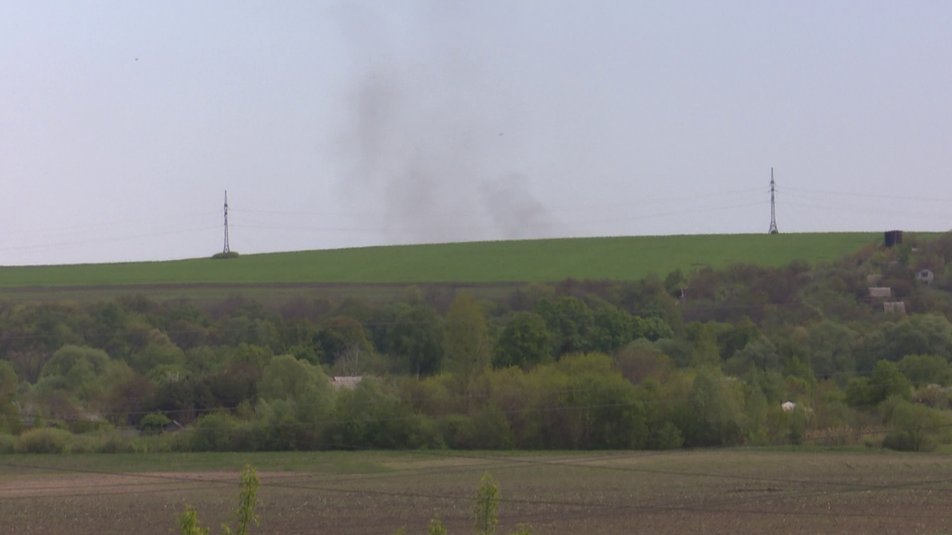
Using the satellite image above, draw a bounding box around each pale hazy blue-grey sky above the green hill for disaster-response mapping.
[0,0,952,265]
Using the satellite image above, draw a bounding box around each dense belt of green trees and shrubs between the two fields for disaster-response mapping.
[0,235,952,451]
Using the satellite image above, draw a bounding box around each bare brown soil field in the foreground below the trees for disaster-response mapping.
[0,450,952,535]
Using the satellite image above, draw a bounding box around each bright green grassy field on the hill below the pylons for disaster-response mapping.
[0,233,882,288]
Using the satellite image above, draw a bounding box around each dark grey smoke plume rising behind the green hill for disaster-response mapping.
[334,2,552,243]
